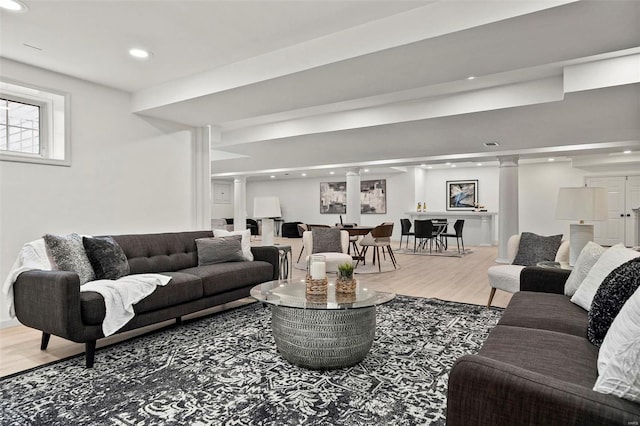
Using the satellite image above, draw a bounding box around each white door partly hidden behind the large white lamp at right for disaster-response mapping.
[587,176,626,246]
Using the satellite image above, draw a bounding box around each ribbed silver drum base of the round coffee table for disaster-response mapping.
[271,305,376,369]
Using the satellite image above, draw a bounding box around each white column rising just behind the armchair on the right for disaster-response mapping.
[496,155,520,263]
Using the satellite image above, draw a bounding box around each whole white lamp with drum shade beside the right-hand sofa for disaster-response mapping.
[556,186,608,266]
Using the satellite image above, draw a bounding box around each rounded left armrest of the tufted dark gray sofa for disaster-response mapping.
[13,270,85,342]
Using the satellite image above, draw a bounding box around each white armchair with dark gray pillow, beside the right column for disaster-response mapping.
[487,232,569,307]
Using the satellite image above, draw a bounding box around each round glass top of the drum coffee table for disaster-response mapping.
[251,280,396,310]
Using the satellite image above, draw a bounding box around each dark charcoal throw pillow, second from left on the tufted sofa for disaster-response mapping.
[82,237,129,280]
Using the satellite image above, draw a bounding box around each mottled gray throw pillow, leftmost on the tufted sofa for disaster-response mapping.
[43,234,95,285]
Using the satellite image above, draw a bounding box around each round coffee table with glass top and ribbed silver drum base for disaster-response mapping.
[251,280,395,369]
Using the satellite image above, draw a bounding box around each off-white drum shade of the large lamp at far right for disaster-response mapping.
[556,186,608,222]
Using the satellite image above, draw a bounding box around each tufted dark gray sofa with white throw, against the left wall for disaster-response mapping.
[14,231,279,367]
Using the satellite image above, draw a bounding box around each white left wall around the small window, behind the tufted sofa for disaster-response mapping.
[0,59,196,326]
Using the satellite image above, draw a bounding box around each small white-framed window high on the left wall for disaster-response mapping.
[0,82,71,165]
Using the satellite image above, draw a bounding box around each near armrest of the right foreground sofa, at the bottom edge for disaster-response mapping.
[447,355,640,426]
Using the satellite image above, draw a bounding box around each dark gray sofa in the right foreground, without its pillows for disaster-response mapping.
[447,267,640,426]
